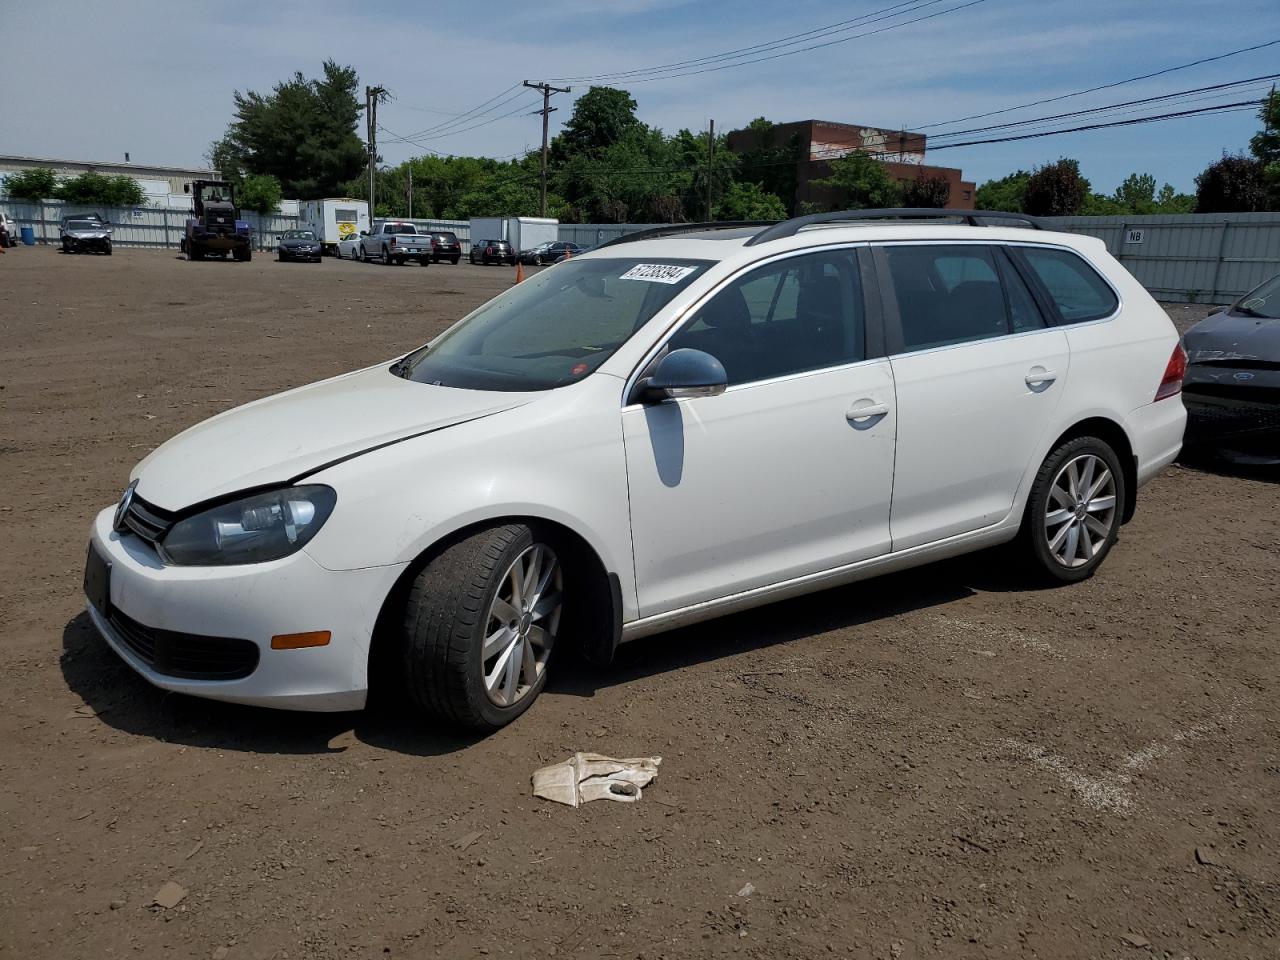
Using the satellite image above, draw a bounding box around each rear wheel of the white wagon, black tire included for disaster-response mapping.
[1019,436,1126,584]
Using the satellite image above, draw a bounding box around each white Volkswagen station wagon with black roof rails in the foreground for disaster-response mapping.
[84,210,1185,728]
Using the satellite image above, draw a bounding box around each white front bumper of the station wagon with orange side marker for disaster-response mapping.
[86,508,404,710]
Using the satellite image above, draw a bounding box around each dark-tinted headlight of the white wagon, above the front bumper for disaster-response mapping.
[160,485,338,567]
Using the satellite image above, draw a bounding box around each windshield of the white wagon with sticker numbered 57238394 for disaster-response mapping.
[393,257,710,390]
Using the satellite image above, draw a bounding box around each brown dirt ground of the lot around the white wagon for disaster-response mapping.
[0,248,1280,960]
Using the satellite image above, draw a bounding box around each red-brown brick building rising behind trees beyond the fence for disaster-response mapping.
[728,120,974,210]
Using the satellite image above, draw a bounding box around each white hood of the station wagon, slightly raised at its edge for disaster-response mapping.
[133,364,532,511]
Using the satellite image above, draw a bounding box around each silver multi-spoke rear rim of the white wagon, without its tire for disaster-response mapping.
[1044,453,1116,568]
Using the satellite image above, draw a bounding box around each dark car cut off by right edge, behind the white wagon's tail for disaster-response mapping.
[1183,276,1280,465]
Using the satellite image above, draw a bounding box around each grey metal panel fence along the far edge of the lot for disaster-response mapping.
[5,200,1280,303]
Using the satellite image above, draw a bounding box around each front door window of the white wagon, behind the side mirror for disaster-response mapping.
[665,250,867,385]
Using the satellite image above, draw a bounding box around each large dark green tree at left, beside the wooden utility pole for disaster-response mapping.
[211,60,367,200]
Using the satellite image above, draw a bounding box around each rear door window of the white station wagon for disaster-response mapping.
[882,243,1044,351]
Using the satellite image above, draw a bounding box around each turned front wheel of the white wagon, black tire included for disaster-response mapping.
[401,524,564,730]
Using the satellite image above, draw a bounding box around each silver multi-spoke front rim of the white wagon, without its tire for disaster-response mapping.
[480,543,564,707]
